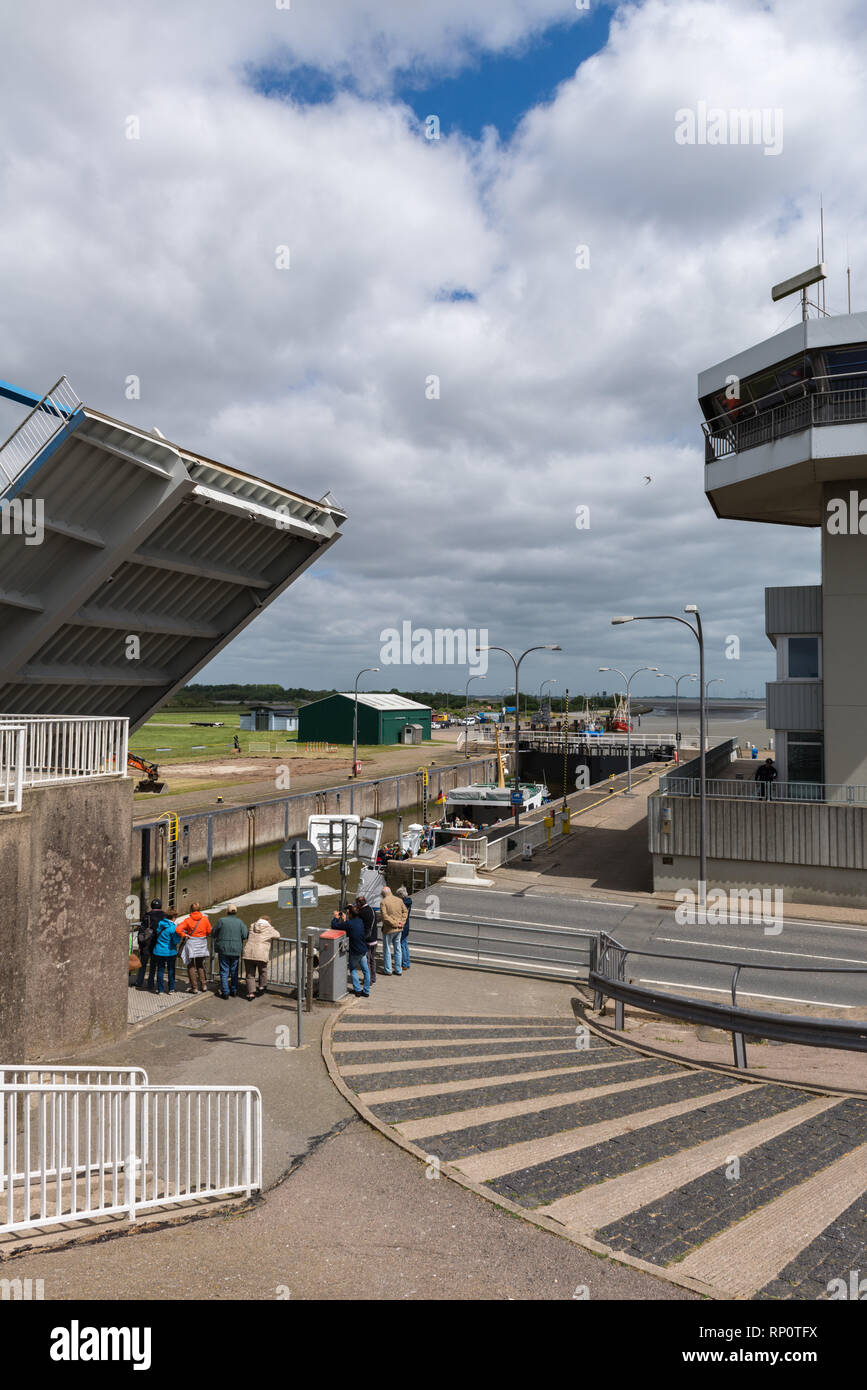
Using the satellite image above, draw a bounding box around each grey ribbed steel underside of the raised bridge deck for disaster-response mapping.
[0,386,346,728]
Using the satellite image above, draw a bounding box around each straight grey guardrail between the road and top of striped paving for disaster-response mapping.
[410,912,596,980]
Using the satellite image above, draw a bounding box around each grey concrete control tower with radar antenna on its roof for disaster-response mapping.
[699,265,867,802]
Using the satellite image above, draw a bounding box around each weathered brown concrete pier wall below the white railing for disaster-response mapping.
[0,777,133,1062]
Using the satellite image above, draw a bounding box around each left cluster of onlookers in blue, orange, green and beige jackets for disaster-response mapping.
[135,898,279,1001]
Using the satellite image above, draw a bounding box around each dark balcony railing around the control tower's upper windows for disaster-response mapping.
[702,373,867,463]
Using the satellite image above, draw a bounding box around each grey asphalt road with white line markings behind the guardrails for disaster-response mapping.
[436,881,867,1019]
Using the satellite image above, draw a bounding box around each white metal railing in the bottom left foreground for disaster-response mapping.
[0,1066,263,1233]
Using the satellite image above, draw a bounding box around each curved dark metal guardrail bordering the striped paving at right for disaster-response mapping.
[589,933,867,1069]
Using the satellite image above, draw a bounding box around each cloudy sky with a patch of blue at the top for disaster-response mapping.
[0,0,867,696]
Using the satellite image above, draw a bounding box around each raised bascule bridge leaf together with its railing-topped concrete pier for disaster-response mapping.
[0,378,346,1061]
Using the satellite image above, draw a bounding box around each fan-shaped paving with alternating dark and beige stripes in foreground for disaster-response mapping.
[331,1009,867,1298]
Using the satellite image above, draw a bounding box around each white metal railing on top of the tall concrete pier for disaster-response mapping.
[0,714,129,810]
